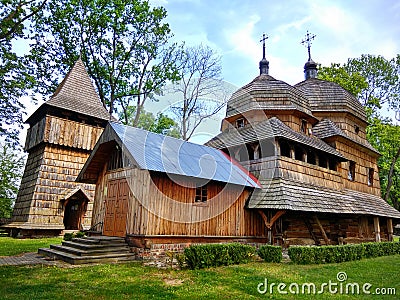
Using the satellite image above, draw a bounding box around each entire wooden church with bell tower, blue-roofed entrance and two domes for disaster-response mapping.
[8,33,400,251]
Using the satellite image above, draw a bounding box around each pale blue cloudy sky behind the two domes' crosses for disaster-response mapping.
[14,0,400,142]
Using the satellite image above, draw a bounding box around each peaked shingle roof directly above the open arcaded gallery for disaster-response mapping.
[206,117,346,160]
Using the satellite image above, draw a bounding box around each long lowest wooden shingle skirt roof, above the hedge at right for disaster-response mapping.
[248,178,400,219]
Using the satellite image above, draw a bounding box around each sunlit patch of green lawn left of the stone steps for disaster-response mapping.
[0,237,62,256]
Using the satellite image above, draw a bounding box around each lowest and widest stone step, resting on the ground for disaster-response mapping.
[38,248,135,265]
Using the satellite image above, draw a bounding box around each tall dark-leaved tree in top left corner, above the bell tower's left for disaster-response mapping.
[0,0,42,148]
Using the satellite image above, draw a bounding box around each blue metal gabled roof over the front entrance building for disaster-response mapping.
[77,122,260,188]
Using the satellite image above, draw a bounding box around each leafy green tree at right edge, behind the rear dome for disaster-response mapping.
[318,55,400,209]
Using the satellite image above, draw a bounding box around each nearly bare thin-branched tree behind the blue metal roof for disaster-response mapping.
[171,45,228,140]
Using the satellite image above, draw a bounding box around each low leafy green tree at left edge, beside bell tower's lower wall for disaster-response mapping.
[0,144,25,218]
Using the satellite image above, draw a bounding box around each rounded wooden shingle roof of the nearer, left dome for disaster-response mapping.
[226,74,312,117]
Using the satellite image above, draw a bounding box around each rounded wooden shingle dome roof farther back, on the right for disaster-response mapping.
[294,78,367,122]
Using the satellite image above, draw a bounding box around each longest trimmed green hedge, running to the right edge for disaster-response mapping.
[289,242,400,264]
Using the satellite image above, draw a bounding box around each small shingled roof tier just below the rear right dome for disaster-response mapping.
[312,119,380,154]
